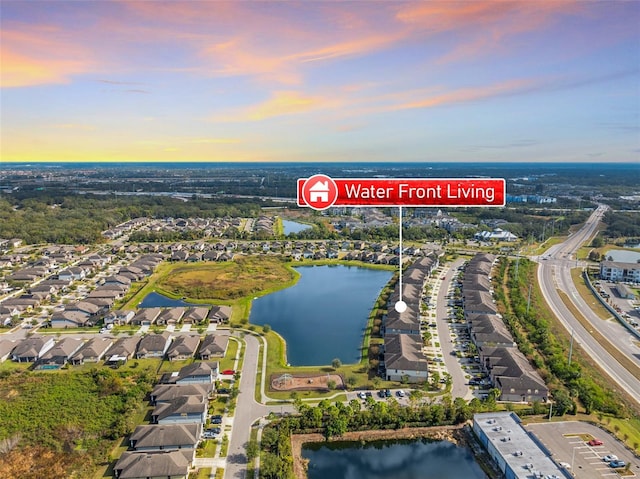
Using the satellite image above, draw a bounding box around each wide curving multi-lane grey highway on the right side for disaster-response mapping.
[538,206,640,404]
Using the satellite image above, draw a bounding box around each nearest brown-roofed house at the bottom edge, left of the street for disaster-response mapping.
[113,450,191,479]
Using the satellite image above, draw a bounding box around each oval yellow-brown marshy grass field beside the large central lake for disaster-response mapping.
[157,256,299,301]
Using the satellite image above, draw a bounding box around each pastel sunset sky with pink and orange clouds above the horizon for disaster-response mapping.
[0,0,640,162]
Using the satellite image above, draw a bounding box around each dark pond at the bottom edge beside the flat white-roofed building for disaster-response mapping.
[302,440,487,479]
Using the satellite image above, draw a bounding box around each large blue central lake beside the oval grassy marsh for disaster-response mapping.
[249,265,393,366]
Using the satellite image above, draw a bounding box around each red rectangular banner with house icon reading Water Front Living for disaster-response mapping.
[298,175,506,210]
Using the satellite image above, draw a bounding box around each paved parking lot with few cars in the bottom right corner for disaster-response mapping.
[525,421,640,479]
